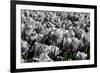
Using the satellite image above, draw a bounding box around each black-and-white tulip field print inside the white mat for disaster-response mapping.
[21,10,90,62]
